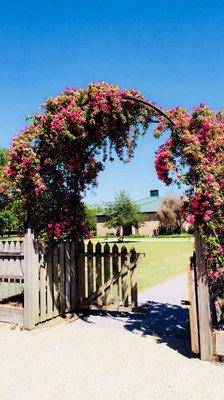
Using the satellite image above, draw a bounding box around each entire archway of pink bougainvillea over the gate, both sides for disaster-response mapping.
[1,82,224,318]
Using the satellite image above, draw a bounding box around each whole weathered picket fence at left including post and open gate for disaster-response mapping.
[0,229,143,330]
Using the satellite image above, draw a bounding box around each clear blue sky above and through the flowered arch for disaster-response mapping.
[0,0,224,203]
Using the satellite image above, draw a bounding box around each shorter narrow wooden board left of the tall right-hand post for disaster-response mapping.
[187,257,199,354]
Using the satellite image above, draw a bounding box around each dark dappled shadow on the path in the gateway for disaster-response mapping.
[81,301,194,358]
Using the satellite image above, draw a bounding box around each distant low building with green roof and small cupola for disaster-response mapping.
[96,190,164,236]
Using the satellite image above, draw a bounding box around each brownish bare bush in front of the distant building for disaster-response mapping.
[157,197,185,234]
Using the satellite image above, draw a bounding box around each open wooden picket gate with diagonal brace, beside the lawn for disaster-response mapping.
[78,242,140,311]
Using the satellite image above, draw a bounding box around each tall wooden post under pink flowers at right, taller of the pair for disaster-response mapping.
[195,229,212,361]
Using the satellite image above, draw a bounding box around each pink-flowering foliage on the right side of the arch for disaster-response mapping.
[155,104,224,302]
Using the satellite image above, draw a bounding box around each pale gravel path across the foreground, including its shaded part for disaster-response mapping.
[0,276,224,400]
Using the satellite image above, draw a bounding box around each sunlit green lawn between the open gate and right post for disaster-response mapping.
[93,239,194,292]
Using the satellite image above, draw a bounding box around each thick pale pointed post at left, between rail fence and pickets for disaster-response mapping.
[24,228,39,330]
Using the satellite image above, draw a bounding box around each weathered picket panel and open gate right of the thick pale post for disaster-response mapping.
[37,240,140,322]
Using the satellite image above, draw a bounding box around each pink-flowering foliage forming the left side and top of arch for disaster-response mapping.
[1,83,158,238]
